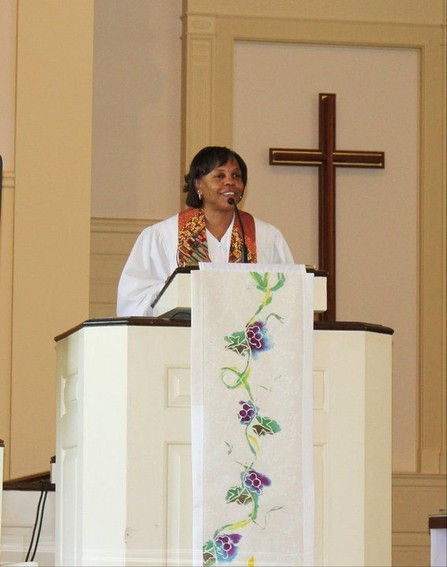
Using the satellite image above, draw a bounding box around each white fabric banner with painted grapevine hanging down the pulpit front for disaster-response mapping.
[191,263,313,567]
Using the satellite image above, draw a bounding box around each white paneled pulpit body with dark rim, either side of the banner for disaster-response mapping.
[55,317,392,567]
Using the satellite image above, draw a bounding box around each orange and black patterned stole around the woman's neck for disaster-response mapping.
[177,208,256,267]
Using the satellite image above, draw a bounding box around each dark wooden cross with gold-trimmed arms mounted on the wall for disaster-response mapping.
[270,93,385,321]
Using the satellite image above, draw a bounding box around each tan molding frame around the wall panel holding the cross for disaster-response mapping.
[182,0,447,473]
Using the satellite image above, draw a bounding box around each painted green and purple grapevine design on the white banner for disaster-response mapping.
[203,272,285,566]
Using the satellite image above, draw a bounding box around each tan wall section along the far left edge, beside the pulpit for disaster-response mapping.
[0,0,93,478]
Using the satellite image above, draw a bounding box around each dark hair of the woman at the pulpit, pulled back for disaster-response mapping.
[183,146,248,208]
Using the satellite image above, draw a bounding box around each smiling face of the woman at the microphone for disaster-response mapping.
[195,159,244,211]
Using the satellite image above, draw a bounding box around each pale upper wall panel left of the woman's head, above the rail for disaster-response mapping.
[92,0,182,219]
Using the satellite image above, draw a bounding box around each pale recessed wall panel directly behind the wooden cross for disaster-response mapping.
[233,42,419,471]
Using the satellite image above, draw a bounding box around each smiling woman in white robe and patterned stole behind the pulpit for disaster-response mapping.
[117,146,293,317]
